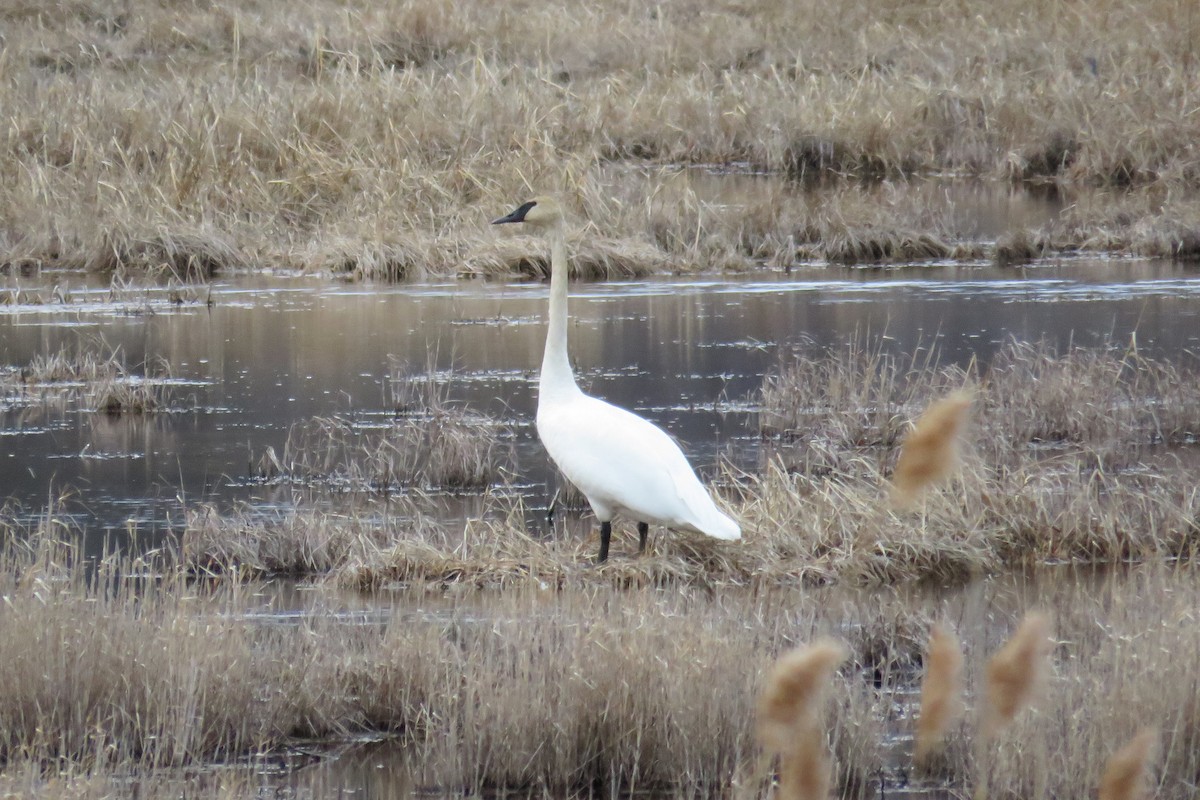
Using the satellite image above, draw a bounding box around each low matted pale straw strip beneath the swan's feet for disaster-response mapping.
[180,434,1200,589]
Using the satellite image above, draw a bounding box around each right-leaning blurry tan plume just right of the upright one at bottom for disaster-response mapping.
[984,612,1051,735]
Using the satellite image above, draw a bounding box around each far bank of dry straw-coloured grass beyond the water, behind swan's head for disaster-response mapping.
[0,0,1200,278]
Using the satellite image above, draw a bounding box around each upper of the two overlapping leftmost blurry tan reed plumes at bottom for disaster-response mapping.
[758,639,848,756]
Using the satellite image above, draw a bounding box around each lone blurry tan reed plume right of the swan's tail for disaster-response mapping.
[892,390,972,507]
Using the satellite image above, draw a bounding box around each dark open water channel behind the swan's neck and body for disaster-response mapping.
[0,259,1200,539]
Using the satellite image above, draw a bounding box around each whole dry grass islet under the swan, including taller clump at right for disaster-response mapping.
[174,335,1200,588]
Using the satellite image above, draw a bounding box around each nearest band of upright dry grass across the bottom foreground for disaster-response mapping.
[0,509,1200,800]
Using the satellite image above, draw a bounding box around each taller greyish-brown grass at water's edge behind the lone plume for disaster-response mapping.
[760,339,1200,473]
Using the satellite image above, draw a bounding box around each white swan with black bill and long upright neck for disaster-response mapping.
[492,197,742,561]
